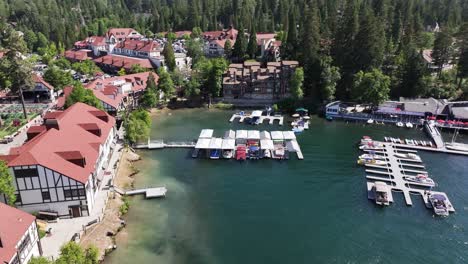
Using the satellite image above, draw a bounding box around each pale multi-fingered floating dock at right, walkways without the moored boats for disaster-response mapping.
[365,141,455,212]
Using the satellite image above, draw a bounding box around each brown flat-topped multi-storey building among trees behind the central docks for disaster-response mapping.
[223,61,299,103]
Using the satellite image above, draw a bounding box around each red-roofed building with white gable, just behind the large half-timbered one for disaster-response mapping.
[85,72,163,116]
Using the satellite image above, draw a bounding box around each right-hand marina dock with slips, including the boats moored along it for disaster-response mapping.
[360,138,455,216]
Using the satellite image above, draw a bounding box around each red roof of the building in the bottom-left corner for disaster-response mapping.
[0,203,36,263]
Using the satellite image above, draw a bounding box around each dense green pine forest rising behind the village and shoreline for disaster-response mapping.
[0,0,468,102]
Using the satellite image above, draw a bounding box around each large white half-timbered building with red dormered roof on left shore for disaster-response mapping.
[0,103,115,218]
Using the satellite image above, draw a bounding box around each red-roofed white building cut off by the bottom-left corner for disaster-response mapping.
[0,203,42,264]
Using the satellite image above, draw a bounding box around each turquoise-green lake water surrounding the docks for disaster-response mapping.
[106,109,468,264]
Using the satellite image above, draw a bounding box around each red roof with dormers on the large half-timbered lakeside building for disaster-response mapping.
[0,103,115,183]
